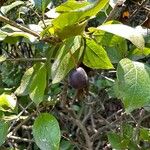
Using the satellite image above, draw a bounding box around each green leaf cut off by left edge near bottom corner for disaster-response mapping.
[0,120,9,146]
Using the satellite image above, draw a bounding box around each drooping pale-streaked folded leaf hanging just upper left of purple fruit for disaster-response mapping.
[52,36,83,84]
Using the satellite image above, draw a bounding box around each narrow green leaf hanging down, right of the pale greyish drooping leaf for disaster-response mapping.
[29,63,47,105]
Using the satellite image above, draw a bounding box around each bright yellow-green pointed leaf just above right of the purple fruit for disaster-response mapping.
[83,39,113,69]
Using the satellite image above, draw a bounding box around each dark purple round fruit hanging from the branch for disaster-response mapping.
[68,67,89,89]
